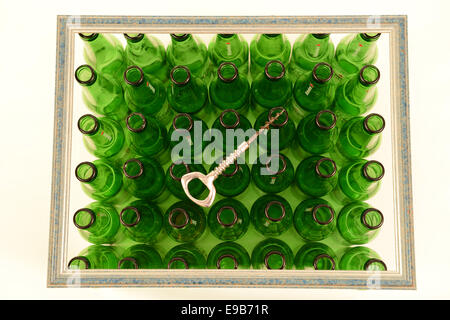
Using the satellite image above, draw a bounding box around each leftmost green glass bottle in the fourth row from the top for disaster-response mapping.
[75,159,128,202]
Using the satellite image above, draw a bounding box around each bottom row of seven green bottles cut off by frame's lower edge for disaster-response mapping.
[68,242,386,271]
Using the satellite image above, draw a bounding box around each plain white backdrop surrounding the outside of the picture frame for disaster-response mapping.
[0,0,450,299]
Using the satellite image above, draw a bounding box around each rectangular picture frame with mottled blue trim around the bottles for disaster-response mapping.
[47,16,416,289]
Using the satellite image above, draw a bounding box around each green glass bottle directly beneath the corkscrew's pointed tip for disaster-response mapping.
[253,107,295,151]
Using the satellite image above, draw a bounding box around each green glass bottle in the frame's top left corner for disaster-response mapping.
[79,33,126,81]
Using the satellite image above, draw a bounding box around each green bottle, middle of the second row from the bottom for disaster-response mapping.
[207,198,250,241]
